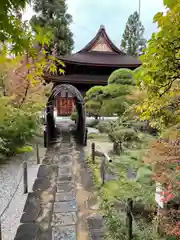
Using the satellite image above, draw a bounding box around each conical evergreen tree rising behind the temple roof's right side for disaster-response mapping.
[121,12,146,56]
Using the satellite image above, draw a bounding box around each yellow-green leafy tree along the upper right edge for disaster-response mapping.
[137,0,180,129]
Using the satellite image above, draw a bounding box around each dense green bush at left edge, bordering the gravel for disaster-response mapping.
[0,102,40,156]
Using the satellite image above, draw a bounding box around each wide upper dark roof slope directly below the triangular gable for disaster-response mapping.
[60,51,141,67]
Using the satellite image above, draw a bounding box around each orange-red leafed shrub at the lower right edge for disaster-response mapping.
[146,126,180,236]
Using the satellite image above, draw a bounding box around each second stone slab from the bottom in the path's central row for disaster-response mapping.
[53,212,77,227]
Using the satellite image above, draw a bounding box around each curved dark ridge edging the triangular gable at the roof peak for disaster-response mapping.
[77,25,126,55]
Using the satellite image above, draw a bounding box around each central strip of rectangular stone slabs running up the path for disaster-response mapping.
[52,135,77,240]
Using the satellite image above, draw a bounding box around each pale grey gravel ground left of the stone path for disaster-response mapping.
[0,143,46,240]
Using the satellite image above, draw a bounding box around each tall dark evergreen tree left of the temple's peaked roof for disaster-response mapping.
[31,0,74,55]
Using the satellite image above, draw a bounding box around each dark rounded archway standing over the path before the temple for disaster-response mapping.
[46,84,87,145]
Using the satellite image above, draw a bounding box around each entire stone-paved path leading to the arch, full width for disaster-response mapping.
[14,124,107,240]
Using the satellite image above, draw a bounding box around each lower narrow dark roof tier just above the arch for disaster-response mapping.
[45,74,109,84]
